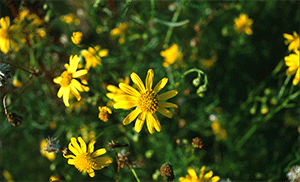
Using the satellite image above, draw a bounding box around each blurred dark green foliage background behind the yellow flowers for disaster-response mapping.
[0,0,300,181]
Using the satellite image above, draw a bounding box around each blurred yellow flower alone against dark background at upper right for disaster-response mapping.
[233,14,253,35]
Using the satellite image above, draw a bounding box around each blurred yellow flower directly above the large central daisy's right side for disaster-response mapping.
[160,44,182,67]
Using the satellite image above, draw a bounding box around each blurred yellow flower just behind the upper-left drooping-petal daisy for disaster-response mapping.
[81,46,108,70]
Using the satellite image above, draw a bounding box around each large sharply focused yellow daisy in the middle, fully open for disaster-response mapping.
[114,69,178,134]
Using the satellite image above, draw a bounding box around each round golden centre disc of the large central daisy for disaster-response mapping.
[138,90,158,114]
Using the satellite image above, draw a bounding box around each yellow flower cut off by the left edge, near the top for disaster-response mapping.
[0,16,19,54]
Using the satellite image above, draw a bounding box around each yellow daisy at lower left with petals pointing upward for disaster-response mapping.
[63,137,113,177]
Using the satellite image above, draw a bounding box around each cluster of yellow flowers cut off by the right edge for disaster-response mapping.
[283,31,300,85]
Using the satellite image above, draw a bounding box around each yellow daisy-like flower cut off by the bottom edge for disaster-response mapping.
[179,166,220,182]
